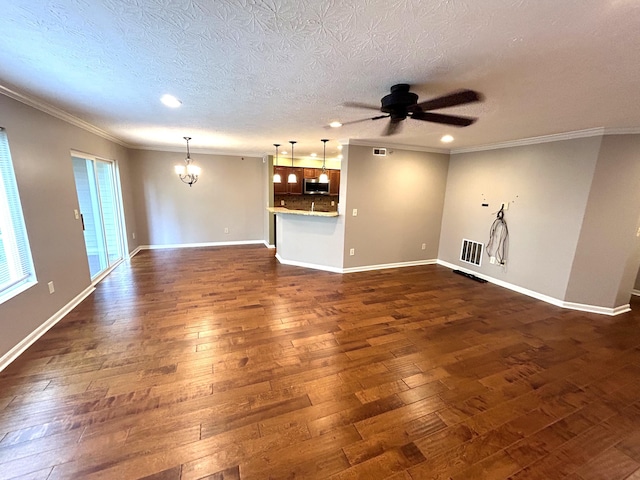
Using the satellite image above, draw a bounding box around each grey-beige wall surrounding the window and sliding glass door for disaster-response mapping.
[0,95,137,358]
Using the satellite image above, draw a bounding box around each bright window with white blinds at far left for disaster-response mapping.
[0,127,36,303]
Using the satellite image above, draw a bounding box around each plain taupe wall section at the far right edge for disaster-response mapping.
[565,135,640,308]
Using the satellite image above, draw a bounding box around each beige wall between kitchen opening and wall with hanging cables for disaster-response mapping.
[340,145,449,268]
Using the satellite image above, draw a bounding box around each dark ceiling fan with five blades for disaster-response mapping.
[342,83,482,136]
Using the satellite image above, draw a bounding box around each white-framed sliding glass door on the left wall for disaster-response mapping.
[71,155,123,279]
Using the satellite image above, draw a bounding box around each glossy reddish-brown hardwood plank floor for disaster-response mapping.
[0,246,640,480]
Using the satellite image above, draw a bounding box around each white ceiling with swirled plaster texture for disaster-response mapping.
[0,0,640,155]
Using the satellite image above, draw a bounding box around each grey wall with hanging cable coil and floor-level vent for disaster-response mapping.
[438,136,602,300]
